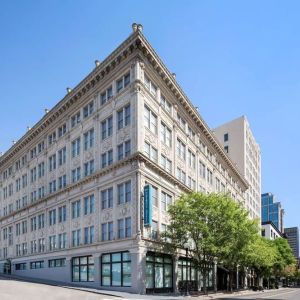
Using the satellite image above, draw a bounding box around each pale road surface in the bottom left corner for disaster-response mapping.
[0,278,120,300]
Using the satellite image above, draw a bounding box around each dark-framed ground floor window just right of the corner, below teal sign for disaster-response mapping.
[146,252,173,292]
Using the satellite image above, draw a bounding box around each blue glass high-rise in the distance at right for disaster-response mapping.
[261,193,284,233]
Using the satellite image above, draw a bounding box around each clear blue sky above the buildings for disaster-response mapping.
[0,0,300,227]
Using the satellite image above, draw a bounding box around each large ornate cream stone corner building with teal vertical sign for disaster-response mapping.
[0,24,248,294]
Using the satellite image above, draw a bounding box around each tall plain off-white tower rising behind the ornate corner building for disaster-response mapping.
[214,116,261,220]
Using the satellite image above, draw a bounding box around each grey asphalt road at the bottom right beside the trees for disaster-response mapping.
[222,288,300,300]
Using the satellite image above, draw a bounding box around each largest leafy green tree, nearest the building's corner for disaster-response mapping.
[165,193,258,293]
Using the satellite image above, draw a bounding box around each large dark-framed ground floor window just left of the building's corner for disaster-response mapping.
[101,251,131,286]
